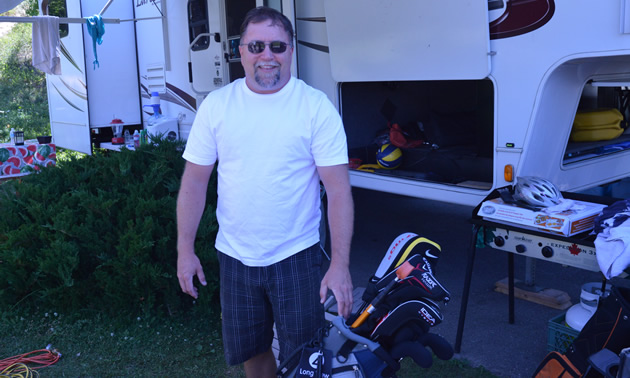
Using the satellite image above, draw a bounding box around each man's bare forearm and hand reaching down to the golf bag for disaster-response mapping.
[317,164,354,318]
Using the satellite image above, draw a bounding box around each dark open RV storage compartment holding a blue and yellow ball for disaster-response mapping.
[340,79,494,188]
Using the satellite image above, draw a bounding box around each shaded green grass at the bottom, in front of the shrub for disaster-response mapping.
[0,311,494,378]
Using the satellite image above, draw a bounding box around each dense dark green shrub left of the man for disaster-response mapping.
[0,140,218,314]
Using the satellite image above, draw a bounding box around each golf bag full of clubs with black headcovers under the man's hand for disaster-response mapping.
[278,233,454,378]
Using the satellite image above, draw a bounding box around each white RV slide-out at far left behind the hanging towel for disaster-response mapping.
[40,0,141,154]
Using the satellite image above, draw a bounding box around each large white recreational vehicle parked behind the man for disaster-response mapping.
[30,0,630,205]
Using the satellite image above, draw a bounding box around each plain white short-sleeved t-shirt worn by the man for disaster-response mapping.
[183,77,348,266]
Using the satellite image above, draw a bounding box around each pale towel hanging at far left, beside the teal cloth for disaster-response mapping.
[33,16,61,75]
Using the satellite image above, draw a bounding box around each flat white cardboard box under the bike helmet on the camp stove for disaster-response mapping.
[477,198,606,236]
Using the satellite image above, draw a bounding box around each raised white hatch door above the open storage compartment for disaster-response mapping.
[324,0,490,82]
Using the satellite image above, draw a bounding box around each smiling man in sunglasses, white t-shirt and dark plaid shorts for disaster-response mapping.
[177,7,354,377]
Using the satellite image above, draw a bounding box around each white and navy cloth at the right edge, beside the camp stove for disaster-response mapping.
[594,200,630,279]
